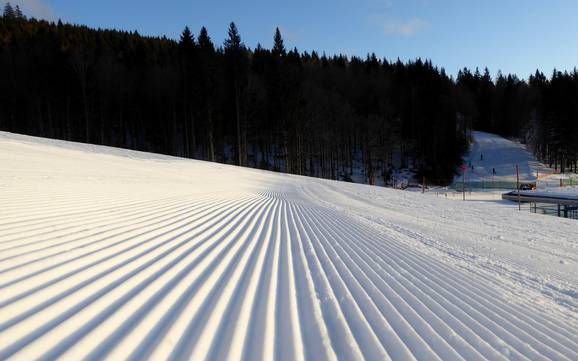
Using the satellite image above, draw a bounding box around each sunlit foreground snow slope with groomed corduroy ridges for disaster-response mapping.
[0,133,578,360]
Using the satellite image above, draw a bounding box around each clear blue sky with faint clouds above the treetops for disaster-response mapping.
[7,0,578,78]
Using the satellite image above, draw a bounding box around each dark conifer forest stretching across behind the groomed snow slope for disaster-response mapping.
[0,4,578,185]
